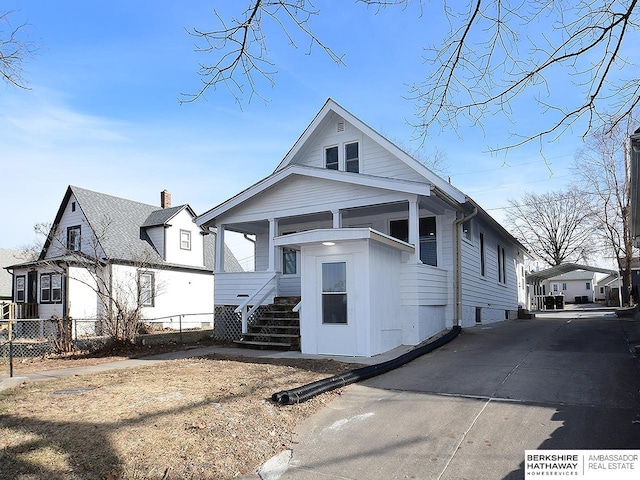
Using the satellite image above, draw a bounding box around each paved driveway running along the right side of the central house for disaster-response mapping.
[274,311,640,480]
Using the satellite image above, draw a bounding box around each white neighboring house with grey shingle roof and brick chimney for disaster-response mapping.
[9,186,239,326]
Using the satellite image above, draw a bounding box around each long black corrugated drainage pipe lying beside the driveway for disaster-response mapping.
[271,325,461,405]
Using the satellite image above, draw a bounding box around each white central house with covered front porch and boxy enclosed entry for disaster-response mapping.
[196,99,526,356]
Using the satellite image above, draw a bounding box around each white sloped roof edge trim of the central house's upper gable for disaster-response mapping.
[275,98,466,203]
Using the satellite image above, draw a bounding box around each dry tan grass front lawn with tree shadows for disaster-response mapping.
[0,357,354,480]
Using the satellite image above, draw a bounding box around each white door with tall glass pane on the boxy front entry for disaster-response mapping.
[316,256,357,355]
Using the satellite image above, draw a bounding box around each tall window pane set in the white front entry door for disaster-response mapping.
[322,262,347,325]
